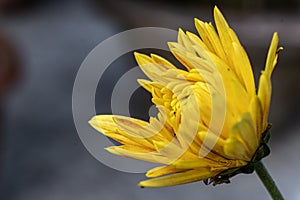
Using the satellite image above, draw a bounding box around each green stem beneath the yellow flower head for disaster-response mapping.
[255,161,284,200]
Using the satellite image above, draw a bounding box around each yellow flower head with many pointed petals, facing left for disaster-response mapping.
[90,7,282,187]
